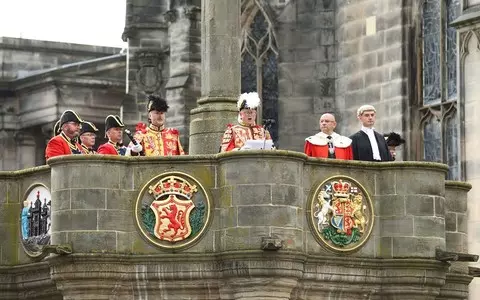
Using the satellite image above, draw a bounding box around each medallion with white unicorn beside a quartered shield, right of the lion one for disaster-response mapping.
[307,176,374,252]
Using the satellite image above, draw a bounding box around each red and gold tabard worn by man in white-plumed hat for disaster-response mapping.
[220,124,272,152]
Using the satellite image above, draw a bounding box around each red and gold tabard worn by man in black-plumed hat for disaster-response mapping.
[134,125,185,156]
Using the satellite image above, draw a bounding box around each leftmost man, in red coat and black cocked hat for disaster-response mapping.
[45,110,83,159]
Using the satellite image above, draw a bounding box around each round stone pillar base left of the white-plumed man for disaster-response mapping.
[188,97,238,155]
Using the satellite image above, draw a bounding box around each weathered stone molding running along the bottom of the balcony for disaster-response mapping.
[37,251,458,299]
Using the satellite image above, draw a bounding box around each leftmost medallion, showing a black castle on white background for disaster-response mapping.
[20,183,52,257]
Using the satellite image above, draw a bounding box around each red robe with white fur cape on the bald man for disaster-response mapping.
[304,132,353,160]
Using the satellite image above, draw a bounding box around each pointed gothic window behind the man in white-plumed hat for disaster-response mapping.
[241,1,278,143]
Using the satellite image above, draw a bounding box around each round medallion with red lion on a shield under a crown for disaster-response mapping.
[135,172,211,250]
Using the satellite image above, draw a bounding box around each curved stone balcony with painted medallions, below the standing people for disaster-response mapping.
[0,151,472,299]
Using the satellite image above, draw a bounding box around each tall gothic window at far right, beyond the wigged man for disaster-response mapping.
[419,0,460,180]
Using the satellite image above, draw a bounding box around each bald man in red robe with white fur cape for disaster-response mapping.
[304,114,353,160]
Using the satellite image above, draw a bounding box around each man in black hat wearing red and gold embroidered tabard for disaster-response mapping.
[129,95,185,156]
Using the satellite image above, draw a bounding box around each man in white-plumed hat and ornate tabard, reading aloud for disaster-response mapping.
[220,92,272,152]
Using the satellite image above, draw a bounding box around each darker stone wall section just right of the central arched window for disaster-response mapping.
[268,1,341,151]
